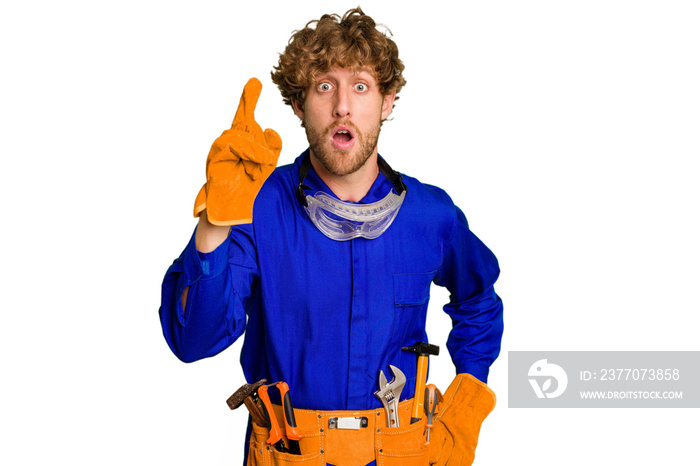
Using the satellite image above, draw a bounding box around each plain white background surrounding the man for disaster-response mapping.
[0,0,700,466]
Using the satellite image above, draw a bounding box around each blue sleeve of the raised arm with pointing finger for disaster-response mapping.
[159,224,259,362]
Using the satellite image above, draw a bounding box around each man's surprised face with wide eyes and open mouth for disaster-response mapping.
[294,68,396,176]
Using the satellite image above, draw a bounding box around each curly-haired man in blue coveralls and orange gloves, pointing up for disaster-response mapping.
[160,8,502,466]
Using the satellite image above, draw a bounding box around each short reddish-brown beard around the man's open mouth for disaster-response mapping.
[302,120,381,176]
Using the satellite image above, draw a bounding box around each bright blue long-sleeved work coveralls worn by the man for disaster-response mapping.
[160,150,503,458]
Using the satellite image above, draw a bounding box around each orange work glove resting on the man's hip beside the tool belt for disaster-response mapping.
[429,374,496,466]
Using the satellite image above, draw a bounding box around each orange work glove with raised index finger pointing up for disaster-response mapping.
[194,78,282,225]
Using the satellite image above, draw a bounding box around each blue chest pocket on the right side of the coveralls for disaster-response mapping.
[392,271,435,352]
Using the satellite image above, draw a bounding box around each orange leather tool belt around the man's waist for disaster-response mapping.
[247,400,432,466]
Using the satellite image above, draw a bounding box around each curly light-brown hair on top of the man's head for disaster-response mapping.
[271,7,406,109]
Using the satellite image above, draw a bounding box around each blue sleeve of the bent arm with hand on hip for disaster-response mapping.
[434,207,503,383]
